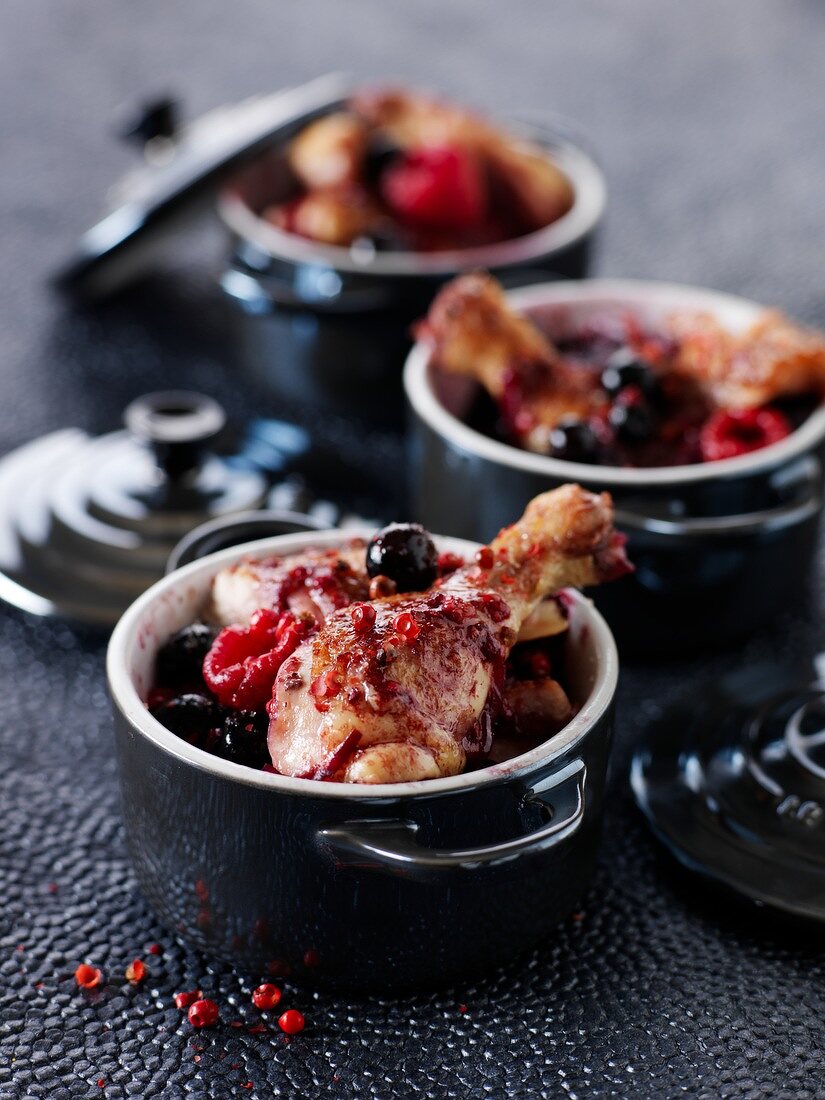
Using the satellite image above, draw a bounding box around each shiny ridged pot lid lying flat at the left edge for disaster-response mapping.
[0,392,270,626]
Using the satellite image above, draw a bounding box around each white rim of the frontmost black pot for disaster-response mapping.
[107,530,618,802]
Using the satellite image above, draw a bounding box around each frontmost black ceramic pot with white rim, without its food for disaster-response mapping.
[108,531,618,990]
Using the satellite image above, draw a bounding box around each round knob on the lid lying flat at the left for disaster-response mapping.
[123,389,227,480]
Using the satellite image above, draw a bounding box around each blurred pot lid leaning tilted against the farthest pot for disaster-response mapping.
[55,75,352,298]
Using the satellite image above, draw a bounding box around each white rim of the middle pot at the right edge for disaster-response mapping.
[404,279,825,488]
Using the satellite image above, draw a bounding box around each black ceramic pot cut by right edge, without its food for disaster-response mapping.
[405,281,825,657]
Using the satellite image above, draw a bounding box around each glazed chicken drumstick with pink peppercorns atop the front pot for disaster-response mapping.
[268,485,629,783]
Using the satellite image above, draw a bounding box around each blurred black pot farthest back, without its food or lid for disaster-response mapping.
[218,121,606,426]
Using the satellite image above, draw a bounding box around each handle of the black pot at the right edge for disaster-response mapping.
[615,455,822,538]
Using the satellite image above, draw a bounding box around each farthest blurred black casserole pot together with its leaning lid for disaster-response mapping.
[55,74,606,425]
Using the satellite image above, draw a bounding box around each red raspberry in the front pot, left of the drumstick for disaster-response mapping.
[204,608,316,711]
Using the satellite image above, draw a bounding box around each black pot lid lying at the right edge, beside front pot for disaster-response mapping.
[630,661,825,921]
